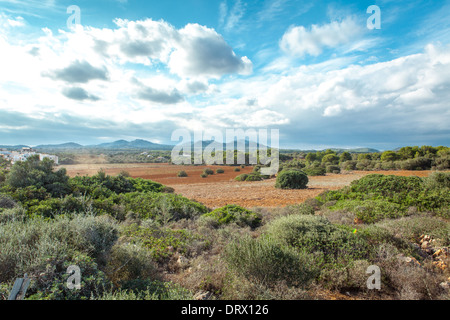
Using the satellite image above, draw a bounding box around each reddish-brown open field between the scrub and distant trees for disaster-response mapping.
[62,164,431,208]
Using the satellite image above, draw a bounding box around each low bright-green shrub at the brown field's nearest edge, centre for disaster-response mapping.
[204,204,261,228]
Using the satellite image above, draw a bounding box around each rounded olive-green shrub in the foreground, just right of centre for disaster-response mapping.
[225,237,318,286]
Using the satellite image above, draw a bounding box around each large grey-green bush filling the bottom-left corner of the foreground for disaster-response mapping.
[0,216,118,299]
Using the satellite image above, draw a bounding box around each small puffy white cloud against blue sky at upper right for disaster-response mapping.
[280,17,367,57]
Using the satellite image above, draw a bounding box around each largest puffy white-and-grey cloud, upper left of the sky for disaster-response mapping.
[79,19,252,78]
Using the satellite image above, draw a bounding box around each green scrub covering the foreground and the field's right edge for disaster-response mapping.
[0,149,450,300]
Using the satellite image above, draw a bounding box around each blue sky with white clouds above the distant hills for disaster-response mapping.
[0,0,450,150]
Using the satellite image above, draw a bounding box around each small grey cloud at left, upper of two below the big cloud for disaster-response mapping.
[47,60,108,83]
